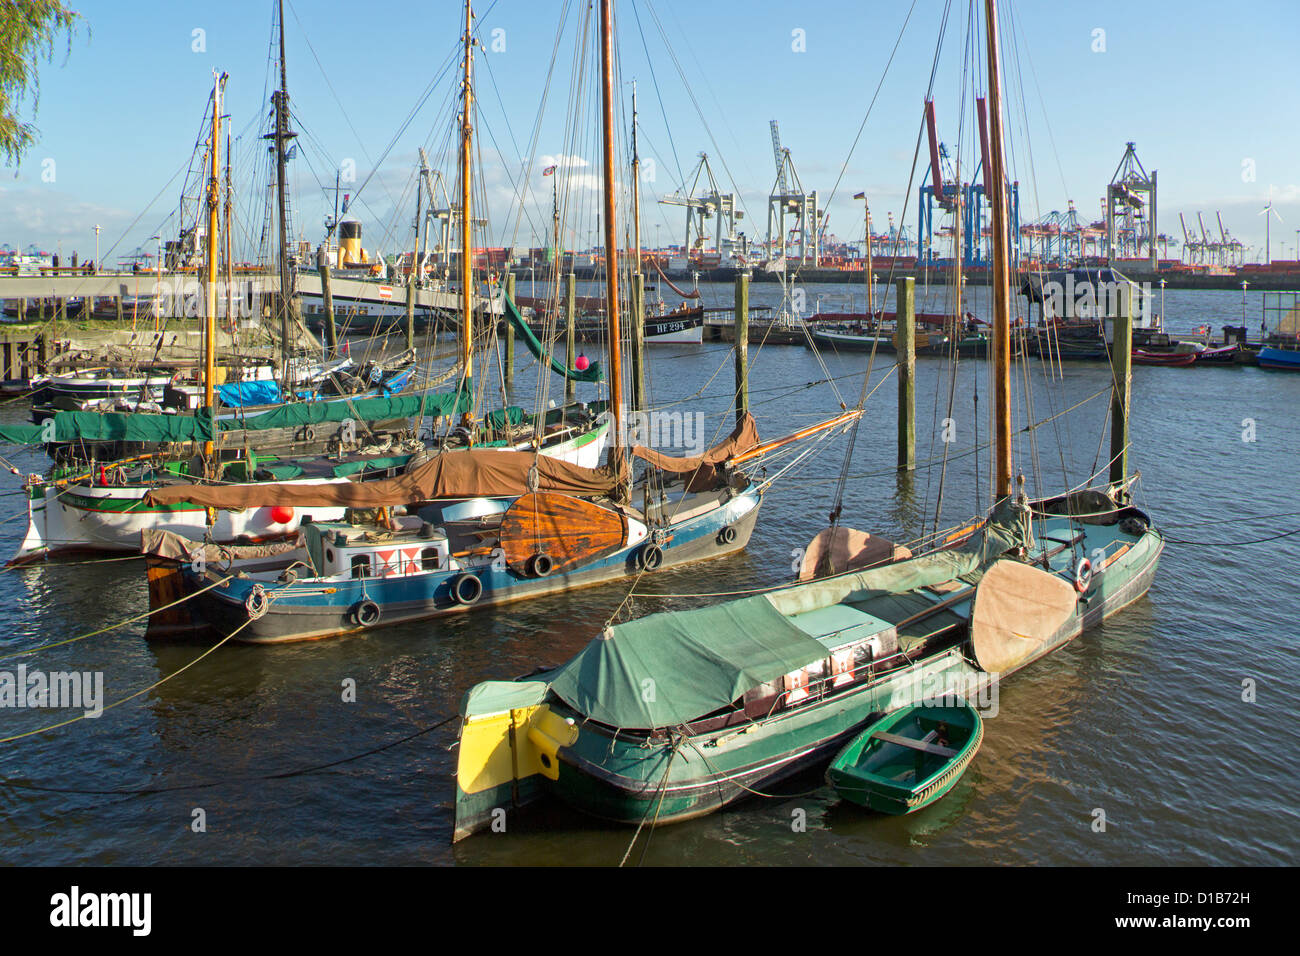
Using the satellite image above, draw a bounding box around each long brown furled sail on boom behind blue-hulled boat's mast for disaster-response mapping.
[144,449,625,509]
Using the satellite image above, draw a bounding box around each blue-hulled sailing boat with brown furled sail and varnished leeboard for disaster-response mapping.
[137,3,861,643]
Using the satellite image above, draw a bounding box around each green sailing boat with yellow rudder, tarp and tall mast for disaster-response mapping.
[454,0,1164,839]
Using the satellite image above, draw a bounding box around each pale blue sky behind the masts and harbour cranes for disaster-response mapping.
[0,0,1300,265]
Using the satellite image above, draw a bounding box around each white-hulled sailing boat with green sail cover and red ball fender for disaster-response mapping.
[0,61,464,563]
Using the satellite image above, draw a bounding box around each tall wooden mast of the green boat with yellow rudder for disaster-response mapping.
[984,0,1011,501]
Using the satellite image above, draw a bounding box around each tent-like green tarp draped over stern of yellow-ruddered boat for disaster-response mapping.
[550,594,827,730]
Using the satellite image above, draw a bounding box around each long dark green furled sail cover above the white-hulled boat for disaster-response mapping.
[0,384,473,445]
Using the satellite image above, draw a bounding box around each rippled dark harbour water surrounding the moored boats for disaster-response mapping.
[0,284,1300,865]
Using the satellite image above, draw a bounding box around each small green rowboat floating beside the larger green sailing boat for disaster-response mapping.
[826,702,984,816]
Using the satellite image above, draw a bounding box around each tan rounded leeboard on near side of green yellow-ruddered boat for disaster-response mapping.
[971,559,1079,674]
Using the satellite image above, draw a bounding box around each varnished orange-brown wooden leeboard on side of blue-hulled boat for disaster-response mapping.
[501,492,628,574]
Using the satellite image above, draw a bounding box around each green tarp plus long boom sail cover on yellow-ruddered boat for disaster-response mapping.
[549,503,1027,730]
